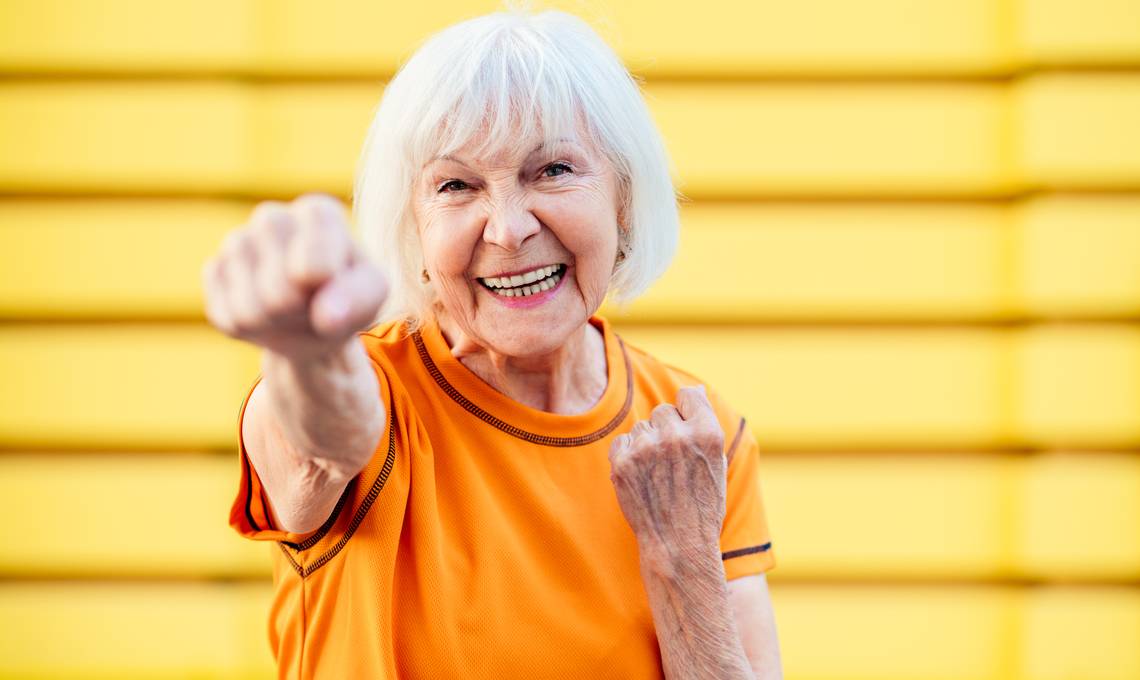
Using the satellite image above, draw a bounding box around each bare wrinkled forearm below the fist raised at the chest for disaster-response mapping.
[641,545,754,680]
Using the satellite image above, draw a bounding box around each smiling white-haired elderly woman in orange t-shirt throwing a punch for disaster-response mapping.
[203,6,781,679]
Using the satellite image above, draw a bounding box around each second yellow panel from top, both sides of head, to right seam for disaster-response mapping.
[0,81,1015,196]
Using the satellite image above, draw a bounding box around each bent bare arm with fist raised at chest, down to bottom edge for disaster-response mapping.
[610,388,782,680]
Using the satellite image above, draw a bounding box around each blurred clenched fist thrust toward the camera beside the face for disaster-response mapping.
[202,194,388,359]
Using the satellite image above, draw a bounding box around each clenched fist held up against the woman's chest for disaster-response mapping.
[610,386,728,559]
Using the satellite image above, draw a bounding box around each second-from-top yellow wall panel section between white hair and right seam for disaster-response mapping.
[648,82,1015,196]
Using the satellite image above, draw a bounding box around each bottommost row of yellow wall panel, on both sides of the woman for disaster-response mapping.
[0,583,1140,680]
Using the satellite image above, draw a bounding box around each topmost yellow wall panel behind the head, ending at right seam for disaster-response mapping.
[0,0,1016,78]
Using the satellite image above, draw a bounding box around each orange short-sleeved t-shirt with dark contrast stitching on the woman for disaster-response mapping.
[229,316,775,680]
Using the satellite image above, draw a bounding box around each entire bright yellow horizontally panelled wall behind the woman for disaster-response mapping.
[0,0,1140,680]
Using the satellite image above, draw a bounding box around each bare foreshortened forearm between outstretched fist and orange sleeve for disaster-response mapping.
[261,337,385,475]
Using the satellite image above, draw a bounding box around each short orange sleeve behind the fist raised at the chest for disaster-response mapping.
[720,418,776,581]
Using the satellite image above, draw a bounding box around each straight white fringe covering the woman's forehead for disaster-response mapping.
[406,17,593,168]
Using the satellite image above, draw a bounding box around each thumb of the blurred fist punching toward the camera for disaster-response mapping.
[309,253,389,338]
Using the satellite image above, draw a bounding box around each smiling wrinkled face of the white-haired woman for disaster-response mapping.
[414,124,619,357]
